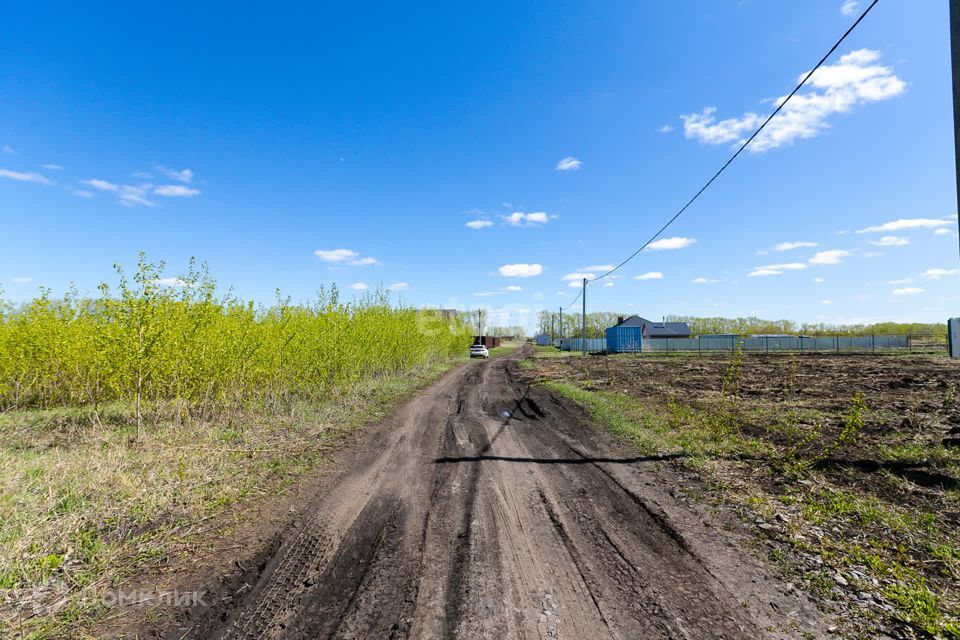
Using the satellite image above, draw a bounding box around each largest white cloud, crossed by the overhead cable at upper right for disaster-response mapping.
[680,49,906,153]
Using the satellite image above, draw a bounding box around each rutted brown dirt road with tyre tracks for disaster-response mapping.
[176,350,823,640]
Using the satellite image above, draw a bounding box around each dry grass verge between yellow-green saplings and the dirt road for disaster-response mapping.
[0,361,464,638]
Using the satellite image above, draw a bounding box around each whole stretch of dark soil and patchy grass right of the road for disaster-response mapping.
[528,354,960,638]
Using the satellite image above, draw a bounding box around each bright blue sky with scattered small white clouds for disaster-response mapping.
[0,0,960,326]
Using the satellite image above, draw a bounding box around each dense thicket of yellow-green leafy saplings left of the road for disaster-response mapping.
[0,254,471,423]
